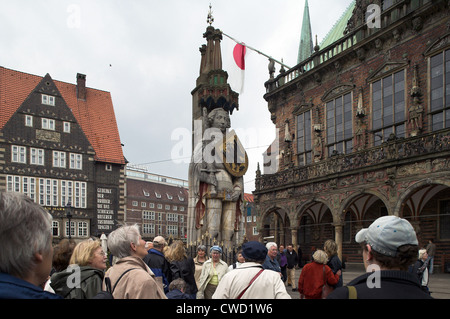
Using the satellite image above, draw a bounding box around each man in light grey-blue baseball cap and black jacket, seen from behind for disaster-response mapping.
[328,216,431,299]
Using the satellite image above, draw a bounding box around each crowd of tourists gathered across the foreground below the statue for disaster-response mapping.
[0,192,431,299]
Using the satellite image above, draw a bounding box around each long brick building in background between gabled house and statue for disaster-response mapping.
[126,166,189,242]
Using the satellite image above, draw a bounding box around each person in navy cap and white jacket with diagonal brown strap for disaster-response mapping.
[212,241,291,299]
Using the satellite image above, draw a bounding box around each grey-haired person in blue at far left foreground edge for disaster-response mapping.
[0,192,61,299]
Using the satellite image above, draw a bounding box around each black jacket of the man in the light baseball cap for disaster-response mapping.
[327,270,432,299]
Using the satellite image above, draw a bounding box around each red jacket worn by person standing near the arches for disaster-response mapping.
[298,261,339,299]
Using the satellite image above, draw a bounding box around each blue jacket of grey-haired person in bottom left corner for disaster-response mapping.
[0,273,62,299]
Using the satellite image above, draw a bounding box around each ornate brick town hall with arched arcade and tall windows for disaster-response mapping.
[254,0,450,270]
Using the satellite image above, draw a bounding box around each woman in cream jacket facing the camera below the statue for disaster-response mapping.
[197,246,228,299]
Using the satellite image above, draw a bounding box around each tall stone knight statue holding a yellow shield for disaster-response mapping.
[188,108,248,247]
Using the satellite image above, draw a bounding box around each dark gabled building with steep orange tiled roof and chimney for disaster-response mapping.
[0,67,125,241]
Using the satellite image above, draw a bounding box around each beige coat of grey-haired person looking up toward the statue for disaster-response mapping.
[103,256,167,299]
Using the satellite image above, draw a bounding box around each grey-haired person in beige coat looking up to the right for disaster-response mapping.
[104,225,167,299]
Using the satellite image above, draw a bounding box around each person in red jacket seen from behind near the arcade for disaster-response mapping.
[298,250,341,299]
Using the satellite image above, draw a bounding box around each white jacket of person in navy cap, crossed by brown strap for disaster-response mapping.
[213,262,291,299]
